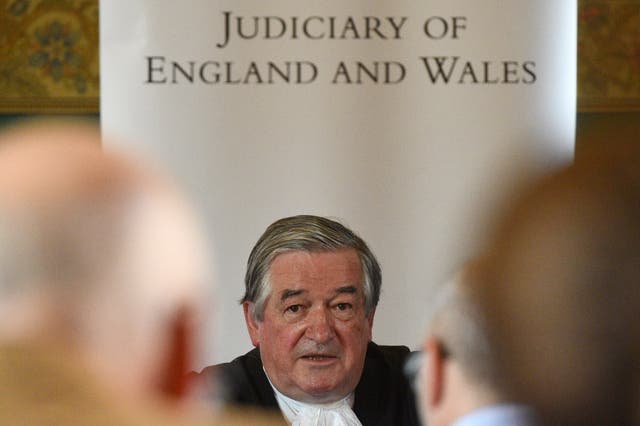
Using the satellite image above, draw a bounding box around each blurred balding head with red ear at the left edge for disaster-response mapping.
[0,123,206,422]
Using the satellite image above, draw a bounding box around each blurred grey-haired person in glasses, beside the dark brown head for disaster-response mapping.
[418,260,536,426]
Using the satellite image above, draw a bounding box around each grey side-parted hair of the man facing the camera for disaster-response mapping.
[241,215,382,321]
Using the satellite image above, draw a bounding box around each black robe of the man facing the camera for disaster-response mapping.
[200,342,420,426]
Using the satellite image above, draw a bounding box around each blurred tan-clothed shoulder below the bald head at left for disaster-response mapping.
[0,344,205,426]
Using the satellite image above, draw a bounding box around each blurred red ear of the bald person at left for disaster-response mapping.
[159,305,196,401]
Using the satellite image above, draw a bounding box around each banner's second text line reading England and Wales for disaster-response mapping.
[144,56,537,85]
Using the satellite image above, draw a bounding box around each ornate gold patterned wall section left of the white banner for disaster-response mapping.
[0,0,100,113]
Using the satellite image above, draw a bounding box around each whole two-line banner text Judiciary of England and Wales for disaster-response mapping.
[144,11,538,85]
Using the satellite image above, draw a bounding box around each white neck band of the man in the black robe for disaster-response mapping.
[265,371,362,426]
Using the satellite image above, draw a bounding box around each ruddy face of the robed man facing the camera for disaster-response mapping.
[245,249,373,403]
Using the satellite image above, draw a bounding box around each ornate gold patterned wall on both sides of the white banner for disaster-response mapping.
[0,0,640,113]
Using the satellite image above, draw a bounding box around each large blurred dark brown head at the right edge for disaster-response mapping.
[482,143,640,425]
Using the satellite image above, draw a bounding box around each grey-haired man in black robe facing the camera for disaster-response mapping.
[205,216,418,426]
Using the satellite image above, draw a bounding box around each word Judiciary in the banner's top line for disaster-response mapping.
[216,12,408,49]
